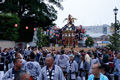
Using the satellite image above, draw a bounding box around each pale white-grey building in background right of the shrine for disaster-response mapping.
[83,24,112,47]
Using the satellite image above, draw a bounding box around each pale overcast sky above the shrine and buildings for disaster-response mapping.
[55,0,120,27]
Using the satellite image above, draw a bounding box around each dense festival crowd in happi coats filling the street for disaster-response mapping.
[0,47,120,80]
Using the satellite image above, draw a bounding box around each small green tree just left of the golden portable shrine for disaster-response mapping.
[34,27,49,47]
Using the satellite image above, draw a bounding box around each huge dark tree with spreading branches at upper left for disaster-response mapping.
[0,0,63,42]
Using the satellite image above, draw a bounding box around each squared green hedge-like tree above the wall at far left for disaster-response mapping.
[0,13,20,41]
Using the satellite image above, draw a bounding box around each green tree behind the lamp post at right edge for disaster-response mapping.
[107,20,120,50]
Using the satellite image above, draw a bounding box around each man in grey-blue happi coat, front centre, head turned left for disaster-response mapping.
[39,56,65,80]
